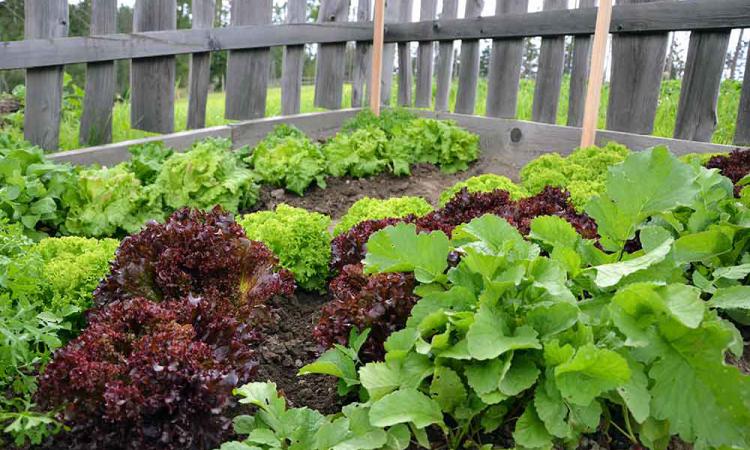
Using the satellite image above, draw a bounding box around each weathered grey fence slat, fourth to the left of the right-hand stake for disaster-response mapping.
[456,0,484,114]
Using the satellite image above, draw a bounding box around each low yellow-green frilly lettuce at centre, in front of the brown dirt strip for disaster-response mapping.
[333,197,432,236]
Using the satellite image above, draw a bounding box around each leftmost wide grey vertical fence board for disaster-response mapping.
[23,0,68,150]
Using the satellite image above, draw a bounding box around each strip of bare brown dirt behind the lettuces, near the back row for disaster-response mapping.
[255,159,517,219]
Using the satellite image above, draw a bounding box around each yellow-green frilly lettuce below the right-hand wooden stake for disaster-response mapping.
[520,142,629,210]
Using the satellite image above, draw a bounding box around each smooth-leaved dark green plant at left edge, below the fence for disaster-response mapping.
[0,143,77,239]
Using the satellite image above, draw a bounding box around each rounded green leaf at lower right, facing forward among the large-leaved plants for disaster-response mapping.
[555,344,631,406]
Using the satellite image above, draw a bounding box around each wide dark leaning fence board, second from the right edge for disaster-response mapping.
[674,31,730,142]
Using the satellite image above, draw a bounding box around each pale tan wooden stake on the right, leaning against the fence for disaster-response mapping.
[581,0,612,147]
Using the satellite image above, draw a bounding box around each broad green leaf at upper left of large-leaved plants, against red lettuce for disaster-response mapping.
[364,223,450,283]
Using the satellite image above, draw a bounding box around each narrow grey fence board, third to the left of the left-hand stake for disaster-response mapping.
[281,0,307,115]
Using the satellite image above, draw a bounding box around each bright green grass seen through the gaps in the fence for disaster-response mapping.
[5,75,741,150]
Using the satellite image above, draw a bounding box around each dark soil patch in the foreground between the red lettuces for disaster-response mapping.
[256,291,342,414]
